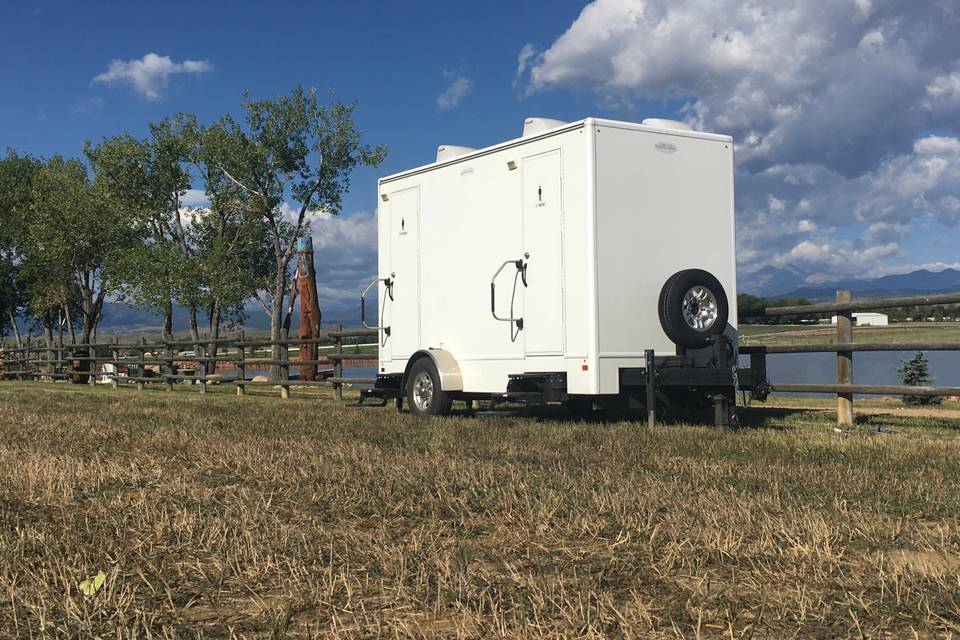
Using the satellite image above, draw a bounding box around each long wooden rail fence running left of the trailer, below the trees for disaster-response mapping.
[0,325,378,399]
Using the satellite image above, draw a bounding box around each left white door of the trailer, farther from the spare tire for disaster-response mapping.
[383,187,420,360]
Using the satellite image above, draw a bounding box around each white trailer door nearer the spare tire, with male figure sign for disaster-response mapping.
[522,149,563,355]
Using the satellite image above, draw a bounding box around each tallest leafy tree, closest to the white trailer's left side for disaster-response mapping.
[210,87,386,376]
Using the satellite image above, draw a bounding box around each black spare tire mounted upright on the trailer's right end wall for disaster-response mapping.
[658,269,730,349]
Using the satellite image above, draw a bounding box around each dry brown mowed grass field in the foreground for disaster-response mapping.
[0,383,960,638]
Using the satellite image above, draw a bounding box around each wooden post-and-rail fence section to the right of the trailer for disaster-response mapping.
[740,290,960,426]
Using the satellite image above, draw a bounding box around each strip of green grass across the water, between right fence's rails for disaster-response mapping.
[737,322,960,345]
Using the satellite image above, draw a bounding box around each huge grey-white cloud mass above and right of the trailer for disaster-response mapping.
[517,0,960,273]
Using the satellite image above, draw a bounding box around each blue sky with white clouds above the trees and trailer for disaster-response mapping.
[0,0,960,301]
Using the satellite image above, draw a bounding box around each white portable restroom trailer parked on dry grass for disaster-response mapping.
[361,118,763,420]
